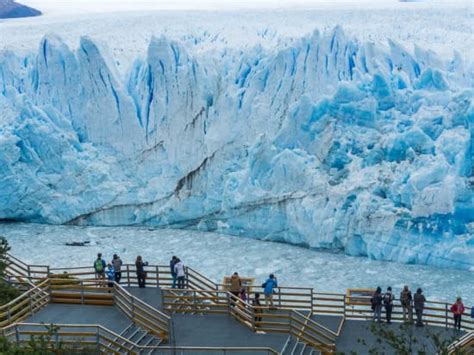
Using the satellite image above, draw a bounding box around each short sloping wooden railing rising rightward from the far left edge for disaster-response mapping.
[0,280,50,328]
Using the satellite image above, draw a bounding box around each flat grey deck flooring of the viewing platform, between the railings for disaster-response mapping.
[27,298,462,355]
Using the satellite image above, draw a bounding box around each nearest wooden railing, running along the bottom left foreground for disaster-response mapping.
[2,323,278,355]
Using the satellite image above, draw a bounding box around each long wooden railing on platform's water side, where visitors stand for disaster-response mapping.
[7,255,474,344]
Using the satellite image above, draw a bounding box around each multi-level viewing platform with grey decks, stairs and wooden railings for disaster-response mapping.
[0,255,474,354]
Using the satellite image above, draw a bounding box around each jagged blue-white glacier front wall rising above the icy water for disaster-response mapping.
[0,27,474,269]
